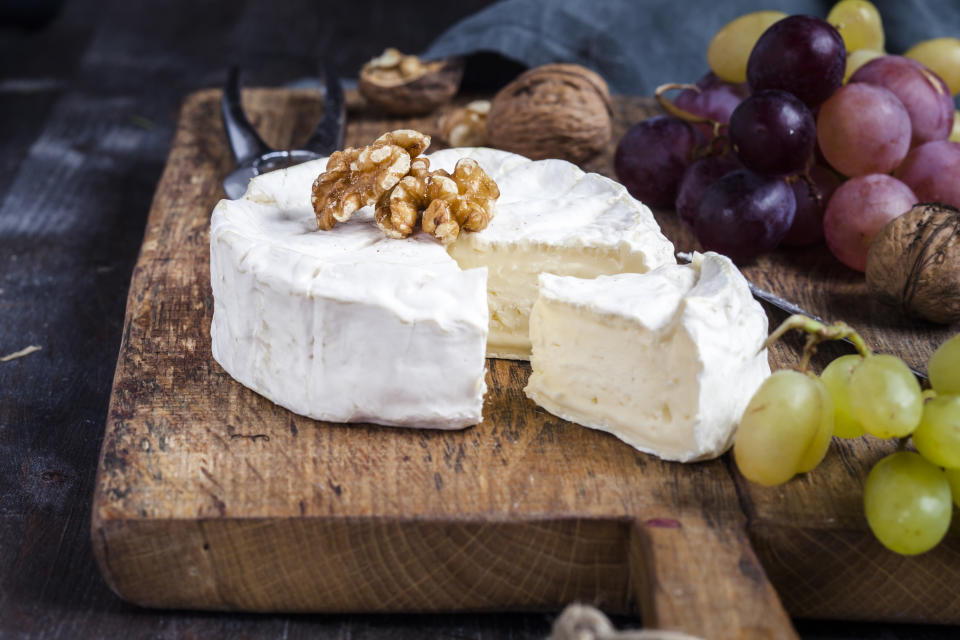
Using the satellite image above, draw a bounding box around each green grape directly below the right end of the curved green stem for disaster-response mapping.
[850,354,923,438]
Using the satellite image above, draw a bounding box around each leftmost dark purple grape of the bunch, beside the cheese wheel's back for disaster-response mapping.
[613,116,702,207]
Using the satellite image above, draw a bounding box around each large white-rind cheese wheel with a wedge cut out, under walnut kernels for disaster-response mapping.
[210,148,675,428]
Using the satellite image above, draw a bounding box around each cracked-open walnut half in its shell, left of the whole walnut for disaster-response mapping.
[357,49,463,116]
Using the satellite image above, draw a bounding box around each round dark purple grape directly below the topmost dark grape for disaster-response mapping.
[729,90,817,175]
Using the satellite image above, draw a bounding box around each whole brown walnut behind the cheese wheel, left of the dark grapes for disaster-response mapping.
[487,64,612,162]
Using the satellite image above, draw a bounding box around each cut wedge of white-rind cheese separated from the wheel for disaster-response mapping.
[525,253,770,462]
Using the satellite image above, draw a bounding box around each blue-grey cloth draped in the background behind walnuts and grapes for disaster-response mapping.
[424,0,960,106]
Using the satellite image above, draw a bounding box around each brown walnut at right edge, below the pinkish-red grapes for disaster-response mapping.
[866,203,960,324]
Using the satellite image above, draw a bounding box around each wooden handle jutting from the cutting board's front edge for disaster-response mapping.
[630,515,799,640]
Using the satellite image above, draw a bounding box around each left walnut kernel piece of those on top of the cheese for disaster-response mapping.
[310,129,430,230]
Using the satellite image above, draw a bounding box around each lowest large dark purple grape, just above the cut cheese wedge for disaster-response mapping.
[694,169,797,262]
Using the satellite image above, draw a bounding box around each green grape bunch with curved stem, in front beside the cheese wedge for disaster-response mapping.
[733,316,960,555]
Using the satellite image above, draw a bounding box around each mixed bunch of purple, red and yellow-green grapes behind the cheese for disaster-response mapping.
[614,0,960,271]
